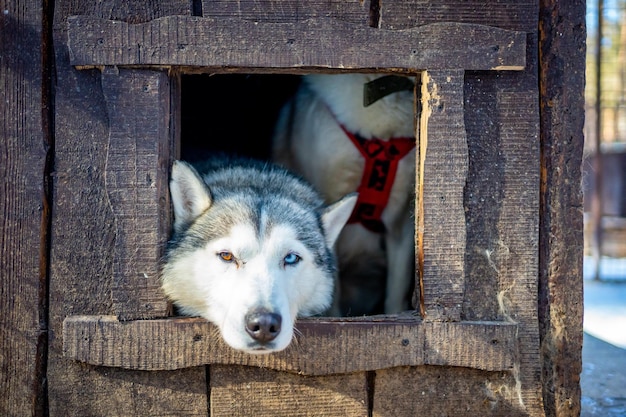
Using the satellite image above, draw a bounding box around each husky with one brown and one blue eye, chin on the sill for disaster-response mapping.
[161,160,356,353]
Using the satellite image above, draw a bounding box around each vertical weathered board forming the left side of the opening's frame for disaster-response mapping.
[102,67,174,320]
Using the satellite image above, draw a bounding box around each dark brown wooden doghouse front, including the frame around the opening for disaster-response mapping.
[0,0,585,416]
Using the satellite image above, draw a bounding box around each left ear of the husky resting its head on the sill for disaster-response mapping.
[170,161,211,230]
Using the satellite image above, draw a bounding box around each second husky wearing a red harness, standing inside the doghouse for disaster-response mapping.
[273,74,415,316]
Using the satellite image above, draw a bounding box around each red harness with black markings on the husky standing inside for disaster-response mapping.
[340,125,415,233]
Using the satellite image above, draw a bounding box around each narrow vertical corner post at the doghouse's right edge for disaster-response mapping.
[539,0,586,417]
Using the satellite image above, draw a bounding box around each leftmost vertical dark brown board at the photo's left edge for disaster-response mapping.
[0,1,50,416]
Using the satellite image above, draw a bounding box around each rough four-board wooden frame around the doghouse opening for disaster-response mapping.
[63,16,527,375]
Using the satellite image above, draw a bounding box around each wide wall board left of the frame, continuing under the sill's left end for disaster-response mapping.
[47,1,208,416]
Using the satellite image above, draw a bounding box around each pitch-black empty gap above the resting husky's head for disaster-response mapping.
[181,74,300,161]
